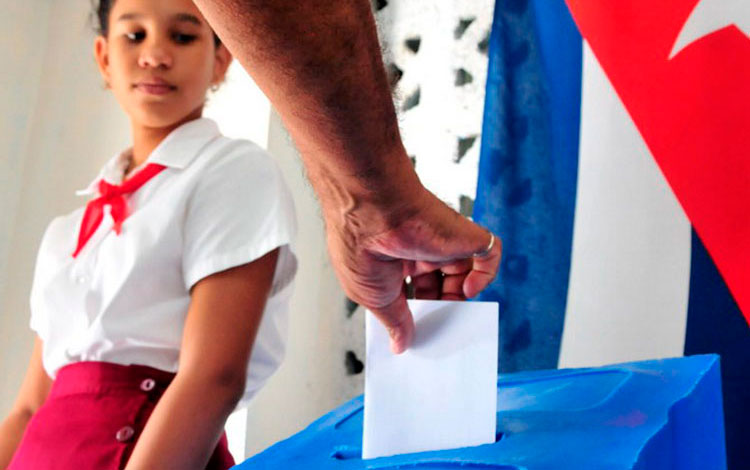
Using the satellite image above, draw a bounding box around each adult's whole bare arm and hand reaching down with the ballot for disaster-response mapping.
[195,0,501,352]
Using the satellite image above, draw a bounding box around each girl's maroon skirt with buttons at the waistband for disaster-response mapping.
[8,362,234,470]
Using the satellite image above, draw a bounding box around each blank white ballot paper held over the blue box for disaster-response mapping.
[362,300,498,459]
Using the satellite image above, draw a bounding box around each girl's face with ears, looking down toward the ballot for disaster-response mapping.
[94,0,231,127]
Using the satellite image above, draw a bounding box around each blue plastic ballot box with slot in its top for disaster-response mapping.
[234,355,726,470]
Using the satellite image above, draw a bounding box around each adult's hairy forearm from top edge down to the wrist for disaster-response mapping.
[196,0,419,210]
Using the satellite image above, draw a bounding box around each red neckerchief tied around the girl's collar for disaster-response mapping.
[73,163,166,258]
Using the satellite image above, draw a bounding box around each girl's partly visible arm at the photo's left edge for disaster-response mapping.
[0,337,52,469]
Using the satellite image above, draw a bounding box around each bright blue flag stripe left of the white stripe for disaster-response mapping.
[474,0,582,372]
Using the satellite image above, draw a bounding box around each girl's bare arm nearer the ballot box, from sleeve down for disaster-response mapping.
[126,250,278,470]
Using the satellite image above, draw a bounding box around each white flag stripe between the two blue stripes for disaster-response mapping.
[559,41,691,367]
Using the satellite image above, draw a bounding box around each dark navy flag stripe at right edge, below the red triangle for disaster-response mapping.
[685,230,750,469]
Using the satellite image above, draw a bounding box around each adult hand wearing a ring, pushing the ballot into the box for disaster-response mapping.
[326,173,502,354]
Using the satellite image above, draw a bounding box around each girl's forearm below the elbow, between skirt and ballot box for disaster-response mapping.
[126,373,243,470]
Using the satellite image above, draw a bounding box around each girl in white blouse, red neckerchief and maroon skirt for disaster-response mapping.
[0,0,296,470]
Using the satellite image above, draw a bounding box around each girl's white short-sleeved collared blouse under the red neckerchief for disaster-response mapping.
[30,119,297,403]
